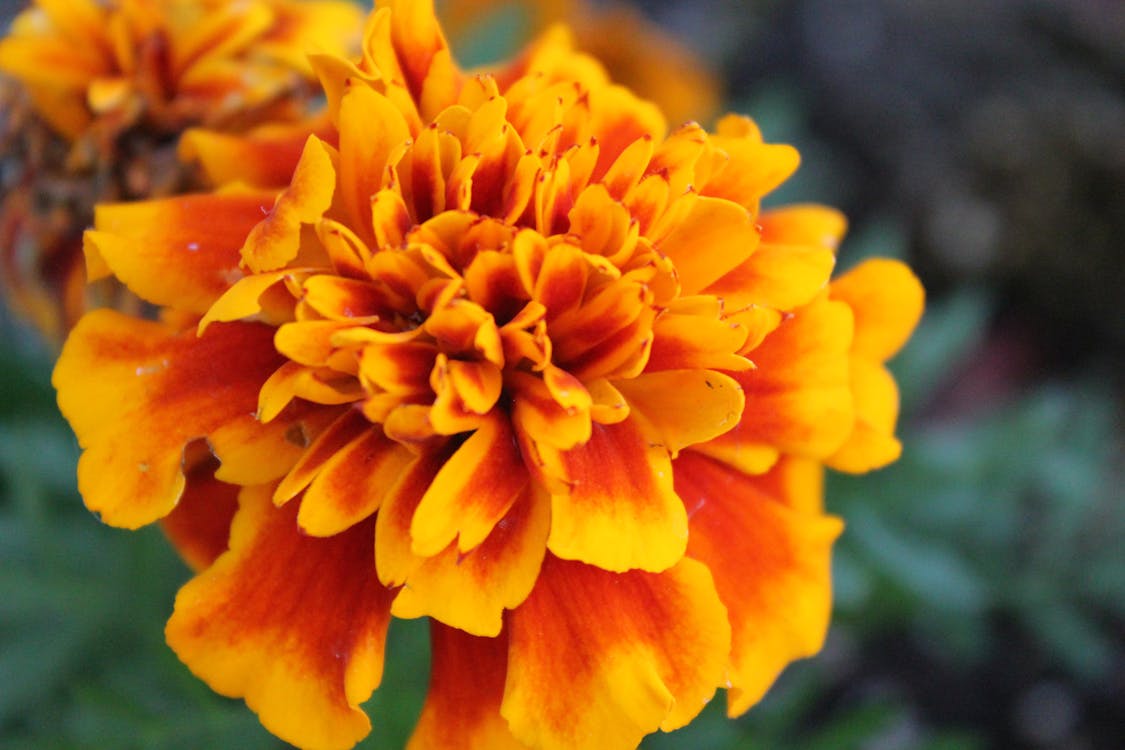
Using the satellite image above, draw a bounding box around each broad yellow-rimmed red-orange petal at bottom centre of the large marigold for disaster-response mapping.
[501,555,730,750]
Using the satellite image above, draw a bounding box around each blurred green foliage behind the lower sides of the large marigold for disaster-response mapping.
[0,3,1125,750]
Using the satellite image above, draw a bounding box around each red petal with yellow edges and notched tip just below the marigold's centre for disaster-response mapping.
[410,415,528,557]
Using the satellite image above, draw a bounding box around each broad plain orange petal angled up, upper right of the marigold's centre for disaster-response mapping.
[656,197,759,295]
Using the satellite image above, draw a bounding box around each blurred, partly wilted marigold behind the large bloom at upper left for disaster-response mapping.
[0,0,361,337]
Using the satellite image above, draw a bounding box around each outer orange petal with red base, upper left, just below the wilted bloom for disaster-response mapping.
[84,193,272,314]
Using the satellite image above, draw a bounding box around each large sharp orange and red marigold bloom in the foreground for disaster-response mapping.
[54,0,921,749]
